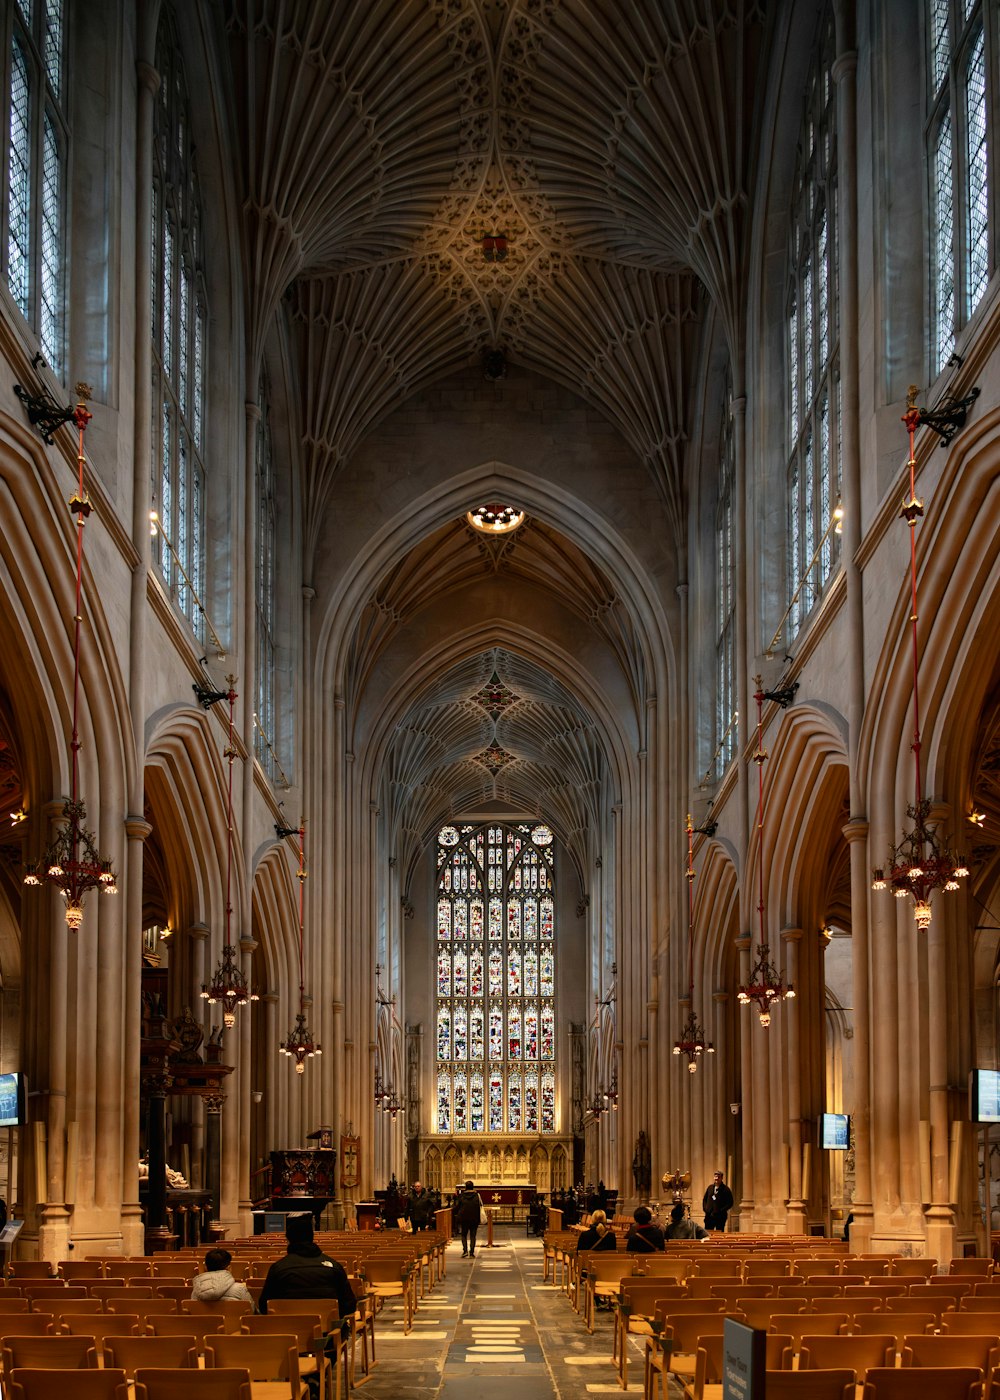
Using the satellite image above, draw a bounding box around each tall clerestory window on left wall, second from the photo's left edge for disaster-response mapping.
[151,8,209,640]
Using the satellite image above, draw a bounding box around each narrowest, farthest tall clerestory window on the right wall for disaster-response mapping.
[713,377,733,777]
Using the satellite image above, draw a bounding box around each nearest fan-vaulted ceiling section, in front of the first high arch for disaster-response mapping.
[222,0,762,557]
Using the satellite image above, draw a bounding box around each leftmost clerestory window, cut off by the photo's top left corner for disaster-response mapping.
[3,0,69,378]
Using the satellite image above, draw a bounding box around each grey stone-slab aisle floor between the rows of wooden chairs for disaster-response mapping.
[359,1229,658,1400]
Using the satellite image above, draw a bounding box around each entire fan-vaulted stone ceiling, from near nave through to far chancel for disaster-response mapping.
[227,0,763,869]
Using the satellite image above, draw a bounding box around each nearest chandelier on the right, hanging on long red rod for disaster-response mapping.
[871,385,969,930]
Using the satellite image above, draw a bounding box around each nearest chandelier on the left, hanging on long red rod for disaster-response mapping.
[24,384,118,931]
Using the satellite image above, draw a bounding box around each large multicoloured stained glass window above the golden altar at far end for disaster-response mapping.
[434,826,556,1134]
